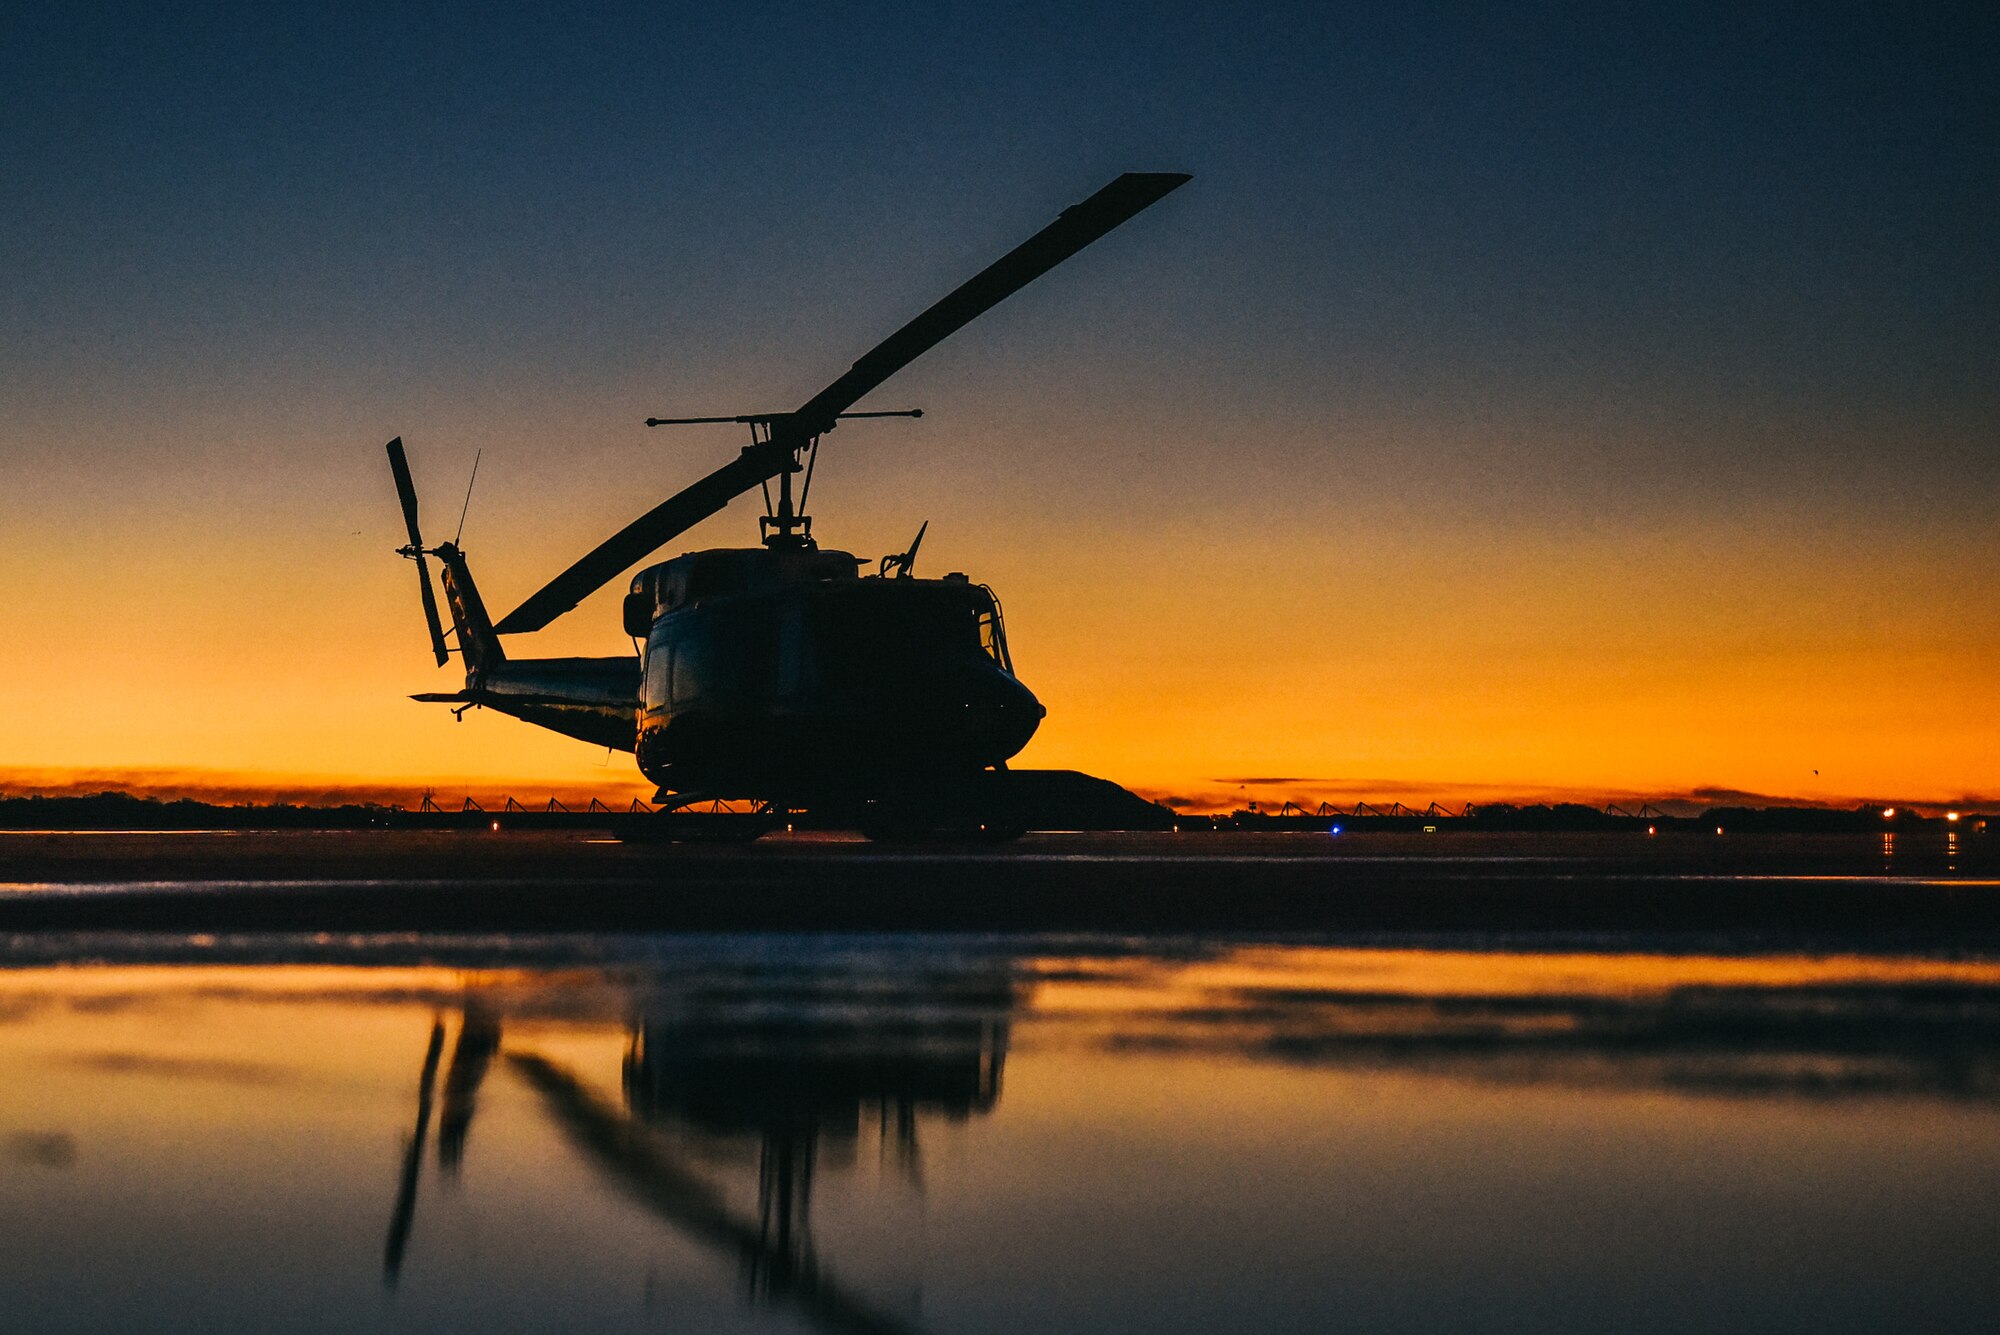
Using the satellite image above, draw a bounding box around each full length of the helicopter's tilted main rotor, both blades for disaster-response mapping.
[494,172,1192,636]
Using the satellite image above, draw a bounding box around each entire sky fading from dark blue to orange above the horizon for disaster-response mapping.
[0,0,2000,805]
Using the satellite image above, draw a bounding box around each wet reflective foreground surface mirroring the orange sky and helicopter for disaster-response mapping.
[0,931,2000,1335]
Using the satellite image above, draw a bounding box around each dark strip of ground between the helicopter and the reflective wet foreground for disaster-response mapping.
[0,829,2000,951]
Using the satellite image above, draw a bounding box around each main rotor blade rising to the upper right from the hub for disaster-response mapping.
[792,172,1194,438]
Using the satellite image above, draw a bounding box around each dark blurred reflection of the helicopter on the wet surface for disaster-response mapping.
[382,959,1020,1333]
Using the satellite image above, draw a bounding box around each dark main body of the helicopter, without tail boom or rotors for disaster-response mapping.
[626,548,1044,801]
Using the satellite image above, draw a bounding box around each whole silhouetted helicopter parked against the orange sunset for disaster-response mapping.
[388,172,1192,837]
